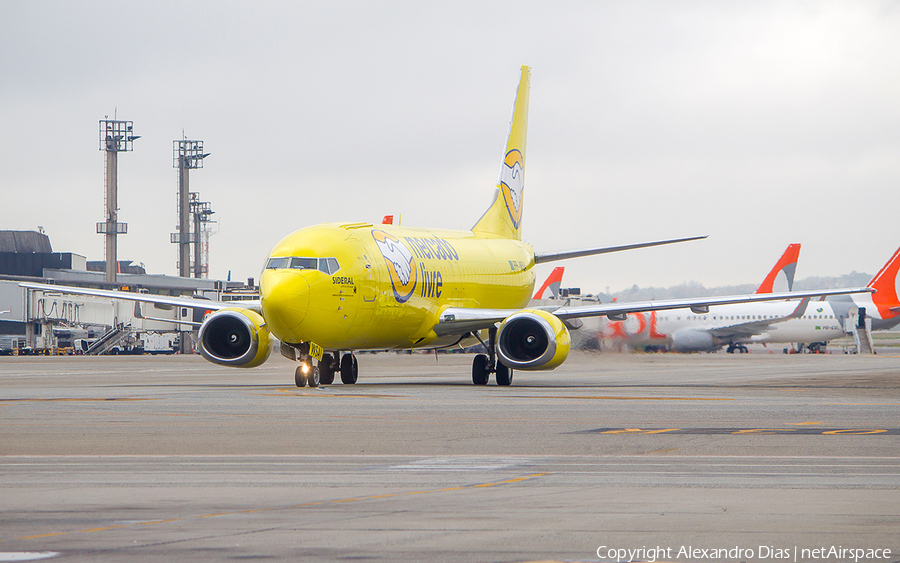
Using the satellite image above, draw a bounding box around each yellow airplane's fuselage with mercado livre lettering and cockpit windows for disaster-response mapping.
[260,223,534,350]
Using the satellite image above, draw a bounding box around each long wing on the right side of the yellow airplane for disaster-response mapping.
[434,287,873,336]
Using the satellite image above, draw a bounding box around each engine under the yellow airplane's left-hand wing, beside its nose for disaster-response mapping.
[199,309,272,368]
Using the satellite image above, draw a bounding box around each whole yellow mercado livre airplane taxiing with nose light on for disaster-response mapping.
[21,66,870,387]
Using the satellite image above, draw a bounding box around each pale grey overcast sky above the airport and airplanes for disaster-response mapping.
[0,0,900,291]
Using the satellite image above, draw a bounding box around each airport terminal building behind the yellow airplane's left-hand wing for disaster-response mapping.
[0,231,251,354]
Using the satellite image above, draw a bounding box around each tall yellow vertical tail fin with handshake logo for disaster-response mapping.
[472,65,531,240]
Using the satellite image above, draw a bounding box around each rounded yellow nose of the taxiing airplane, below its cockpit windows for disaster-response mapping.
[259,270,309,342]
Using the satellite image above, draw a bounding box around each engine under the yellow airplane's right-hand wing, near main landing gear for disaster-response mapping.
[497,309,571,370]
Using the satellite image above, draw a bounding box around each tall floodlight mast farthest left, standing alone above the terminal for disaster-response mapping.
[97,119,140,283]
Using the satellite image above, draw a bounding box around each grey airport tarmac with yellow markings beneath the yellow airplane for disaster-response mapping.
[0,353,900,563]
